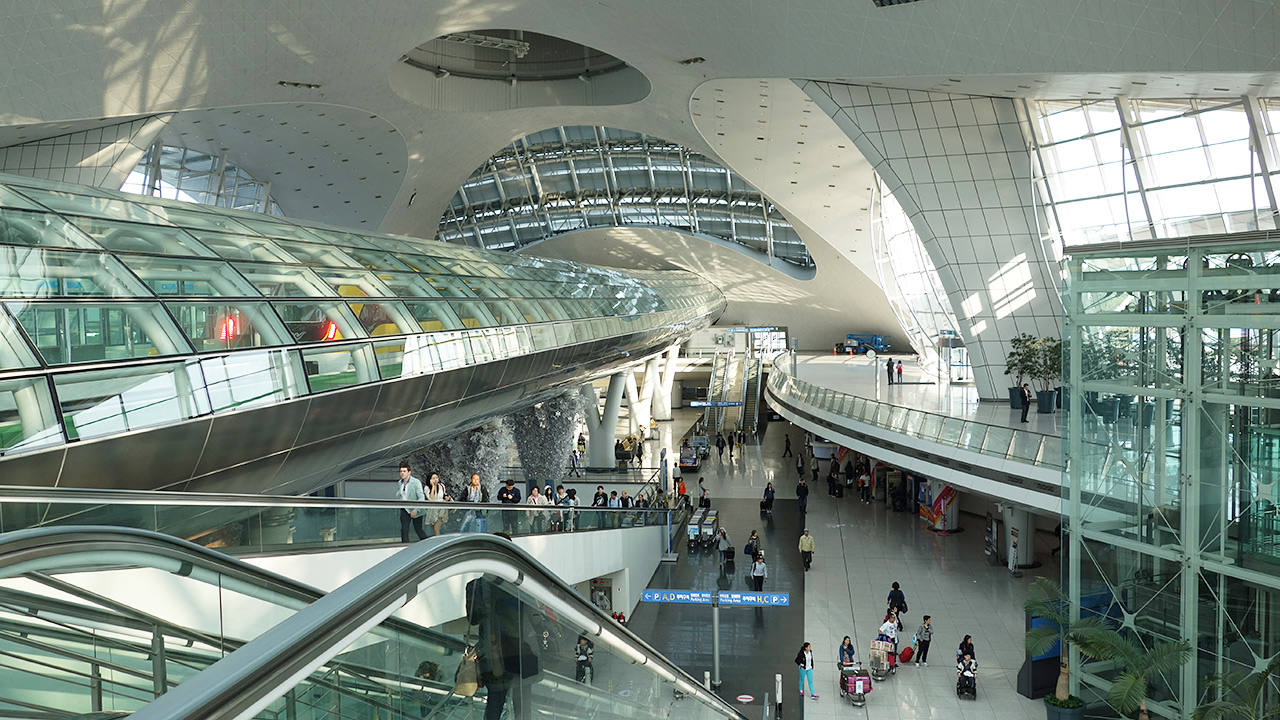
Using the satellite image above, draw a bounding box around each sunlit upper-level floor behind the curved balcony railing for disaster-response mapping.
[796,354,1062,436]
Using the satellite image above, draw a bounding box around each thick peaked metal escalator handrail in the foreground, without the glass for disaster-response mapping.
[133,536,745,720]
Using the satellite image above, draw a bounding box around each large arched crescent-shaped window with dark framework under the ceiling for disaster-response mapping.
[436,126,813,268]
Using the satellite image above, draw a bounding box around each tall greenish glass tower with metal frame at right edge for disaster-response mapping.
[1064,238,1280,717]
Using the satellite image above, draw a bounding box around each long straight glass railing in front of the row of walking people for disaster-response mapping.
[0,486,682,555]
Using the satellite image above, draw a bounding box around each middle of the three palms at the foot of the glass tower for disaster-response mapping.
[1075,624,1192,720]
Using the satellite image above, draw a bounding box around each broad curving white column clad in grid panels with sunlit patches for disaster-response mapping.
[801,82,1061,400]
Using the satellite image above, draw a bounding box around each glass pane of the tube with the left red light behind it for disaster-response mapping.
[165,302,293,352]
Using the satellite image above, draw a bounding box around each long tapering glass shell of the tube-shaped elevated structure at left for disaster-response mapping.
[0,170,723,459]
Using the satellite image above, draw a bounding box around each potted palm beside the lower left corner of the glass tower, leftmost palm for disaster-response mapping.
[1023,578,1106,720]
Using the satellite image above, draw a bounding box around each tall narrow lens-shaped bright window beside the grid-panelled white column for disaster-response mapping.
[872,177,965,378]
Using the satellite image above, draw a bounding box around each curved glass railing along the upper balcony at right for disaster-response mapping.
[768,363,1062,469]
